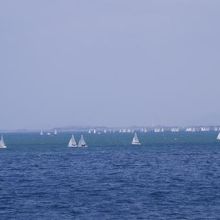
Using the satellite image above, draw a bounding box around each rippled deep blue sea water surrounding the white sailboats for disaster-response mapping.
[0,132,220,220]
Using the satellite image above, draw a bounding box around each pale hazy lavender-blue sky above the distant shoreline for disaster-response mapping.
[0,0,220,129]
